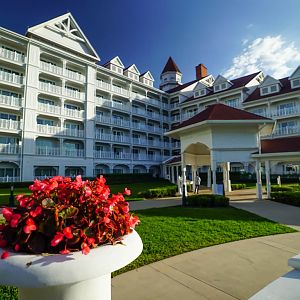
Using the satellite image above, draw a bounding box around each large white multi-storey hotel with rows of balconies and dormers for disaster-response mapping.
[0,13,300,182]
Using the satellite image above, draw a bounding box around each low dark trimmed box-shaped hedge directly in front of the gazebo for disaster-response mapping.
[187,195,229,207]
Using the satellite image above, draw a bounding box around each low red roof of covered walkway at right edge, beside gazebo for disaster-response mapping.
[261,136,300,154]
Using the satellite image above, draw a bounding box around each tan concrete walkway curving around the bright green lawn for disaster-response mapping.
[112,191,300,300]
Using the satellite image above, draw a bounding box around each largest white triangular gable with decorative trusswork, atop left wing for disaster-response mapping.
[26,13,100,61]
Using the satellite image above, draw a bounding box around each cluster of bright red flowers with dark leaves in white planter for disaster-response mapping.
[0,176,139,258]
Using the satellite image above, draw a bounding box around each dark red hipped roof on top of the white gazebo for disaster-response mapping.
[174,103,270,130]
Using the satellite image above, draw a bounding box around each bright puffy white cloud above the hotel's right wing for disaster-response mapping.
[224,35,300,78]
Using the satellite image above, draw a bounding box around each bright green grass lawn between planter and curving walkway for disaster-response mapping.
[0,207,295,300]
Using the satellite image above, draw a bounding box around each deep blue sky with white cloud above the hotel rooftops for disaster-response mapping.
[0,0,300,86]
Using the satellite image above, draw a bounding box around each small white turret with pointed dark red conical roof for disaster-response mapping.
[159,56,182,91]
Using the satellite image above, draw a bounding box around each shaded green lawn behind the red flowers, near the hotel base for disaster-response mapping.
[0,180,174,206]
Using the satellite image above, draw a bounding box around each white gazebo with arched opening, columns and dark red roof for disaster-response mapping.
[165,103,275,199]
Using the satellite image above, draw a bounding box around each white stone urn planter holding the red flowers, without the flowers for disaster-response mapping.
[0,231,143,300]
